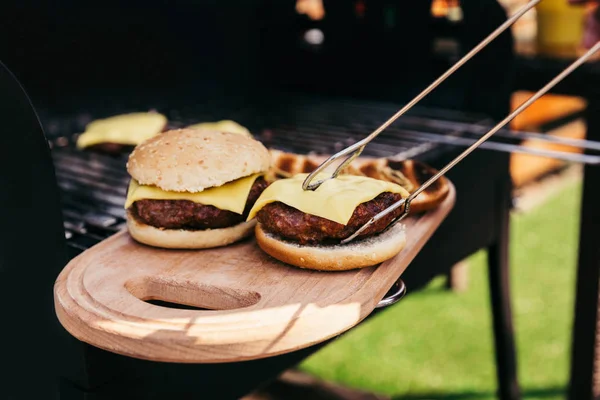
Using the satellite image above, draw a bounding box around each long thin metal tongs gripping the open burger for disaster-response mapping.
[302,0,600,244]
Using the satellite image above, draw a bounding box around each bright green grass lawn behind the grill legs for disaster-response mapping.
[301,183,581,400]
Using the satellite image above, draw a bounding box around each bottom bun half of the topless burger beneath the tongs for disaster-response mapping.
[255,224,406,271]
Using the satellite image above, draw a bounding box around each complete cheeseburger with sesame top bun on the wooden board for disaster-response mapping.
[125,129,270,249]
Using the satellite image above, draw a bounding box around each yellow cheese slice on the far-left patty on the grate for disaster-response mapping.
[77,112,167,149]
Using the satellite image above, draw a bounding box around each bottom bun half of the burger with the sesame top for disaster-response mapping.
[127,212,256,249]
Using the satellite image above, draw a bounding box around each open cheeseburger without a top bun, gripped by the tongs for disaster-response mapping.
[248,174,409,270]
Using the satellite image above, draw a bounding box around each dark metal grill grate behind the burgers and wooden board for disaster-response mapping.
[42,97,487,256]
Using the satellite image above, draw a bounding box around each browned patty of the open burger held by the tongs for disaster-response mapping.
[256,192,402,244]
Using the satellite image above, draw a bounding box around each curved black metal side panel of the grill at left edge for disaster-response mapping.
[0,63,83,399]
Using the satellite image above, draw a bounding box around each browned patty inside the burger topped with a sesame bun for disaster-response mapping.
[136,177,268,230]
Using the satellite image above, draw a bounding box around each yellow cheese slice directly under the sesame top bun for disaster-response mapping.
[125,173,262,214]
